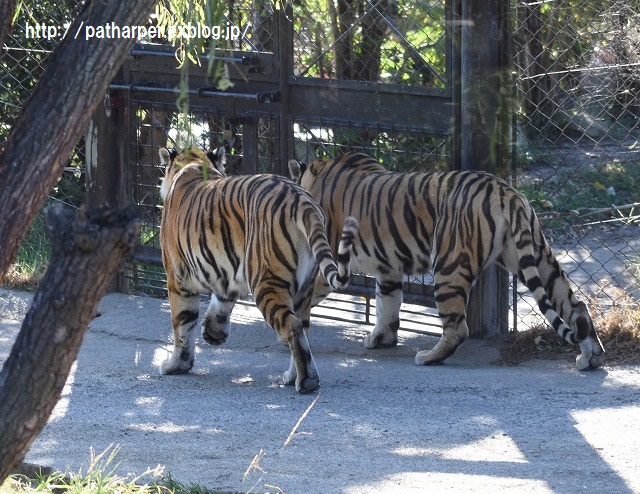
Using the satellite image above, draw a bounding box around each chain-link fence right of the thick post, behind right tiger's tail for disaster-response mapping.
[512,0,640,332]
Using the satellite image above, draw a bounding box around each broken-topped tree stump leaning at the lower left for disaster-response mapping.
[0,204,138,484]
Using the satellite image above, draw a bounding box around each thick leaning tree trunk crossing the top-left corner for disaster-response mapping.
[0,0,157,283]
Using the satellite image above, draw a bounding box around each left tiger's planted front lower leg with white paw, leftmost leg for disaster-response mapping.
[160,289,200,374]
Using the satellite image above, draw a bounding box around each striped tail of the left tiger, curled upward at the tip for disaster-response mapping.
[309,216,358,290]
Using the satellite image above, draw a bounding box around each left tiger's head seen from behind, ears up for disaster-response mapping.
[159,146,227,201]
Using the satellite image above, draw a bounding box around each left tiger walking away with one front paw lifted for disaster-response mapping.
[159,147,358,393]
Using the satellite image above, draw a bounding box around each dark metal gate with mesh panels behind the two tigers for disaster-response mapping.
[89,0,512,338]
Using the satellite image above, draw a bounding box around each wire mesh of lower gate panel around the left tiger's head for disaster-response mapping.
[125,99,277,296]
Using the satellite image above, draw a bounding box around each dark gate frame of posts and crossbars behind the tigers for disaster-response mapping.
[87,0,511,337]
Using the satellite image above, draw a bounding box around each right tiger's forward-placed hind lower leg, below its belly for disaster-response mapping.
[415,274,469,365]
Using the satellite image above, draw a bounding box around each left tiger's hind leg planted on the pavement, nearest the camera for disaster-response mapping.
[253,280,320,394]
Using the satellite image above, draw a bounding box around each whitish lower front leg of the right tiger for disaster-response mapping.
[364,278,402,348]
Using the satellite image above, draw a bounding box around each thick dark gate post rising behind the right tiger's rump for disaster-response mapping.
[460,0,509,338]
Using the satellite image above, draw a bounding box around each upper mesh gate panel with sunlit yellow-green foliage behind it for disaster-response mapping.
[294,0,448,88]
